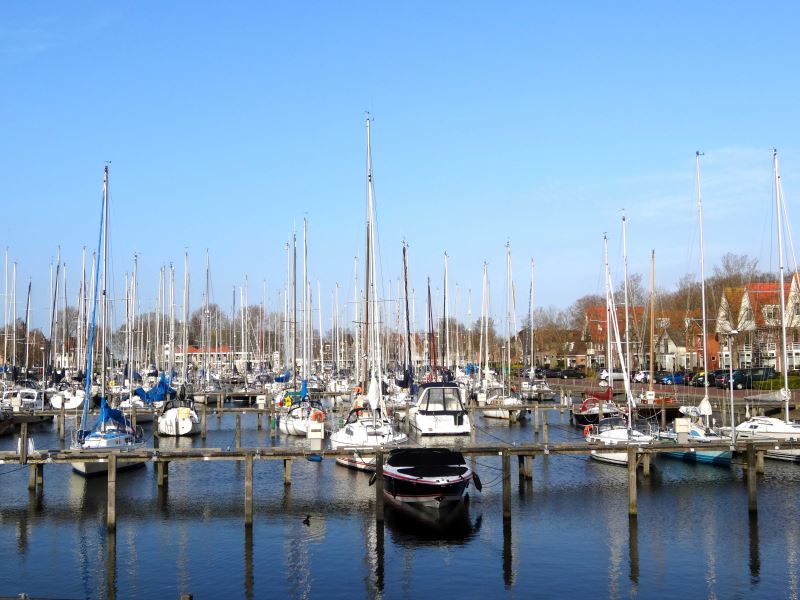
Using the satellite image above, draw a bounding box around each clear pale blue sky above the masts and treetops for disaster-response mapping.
[0,1,800,324]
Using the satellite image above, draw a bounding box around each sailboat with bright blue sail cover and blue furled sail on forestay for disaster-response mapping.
[71,166,145,475]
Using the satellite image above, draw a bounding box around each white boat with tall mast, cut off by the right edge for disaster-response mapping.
[731,150,800,461]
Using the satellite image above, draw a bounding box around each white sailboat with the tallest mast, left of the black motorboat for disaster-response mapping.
[330,117,408,471]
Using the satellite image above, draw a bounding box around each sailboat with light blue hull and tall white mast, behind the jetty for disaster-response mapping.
[650,152,733,465]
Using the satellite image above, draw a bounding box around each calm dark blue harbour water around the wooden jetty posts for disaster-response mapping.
[0,404,800,599]
